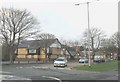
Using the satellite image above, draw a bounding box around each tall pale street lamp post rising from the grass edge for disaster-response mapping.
[75,0,99,67]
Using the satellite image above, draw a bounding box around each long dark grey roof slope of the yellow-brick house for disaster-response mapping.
[18,39,58,49]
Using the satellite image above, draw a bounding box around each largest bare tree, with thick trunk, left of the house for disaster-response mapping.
[0,8,39,63]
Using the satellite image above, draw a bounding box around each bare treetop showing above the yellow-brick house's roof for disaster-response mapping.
[35,33,56,40]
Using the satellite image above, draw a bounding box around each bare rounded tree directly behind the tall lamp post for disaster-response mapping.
[84,28,105,57]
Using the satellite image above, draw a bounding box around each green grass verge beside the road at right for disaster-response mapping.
[74,60,118,72]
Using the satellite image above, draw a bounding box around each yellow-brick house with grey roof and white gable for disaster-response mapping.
[16,39,65,62]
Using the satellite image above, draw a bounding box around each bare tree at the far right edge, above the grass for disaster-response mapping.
[97,32,120,55]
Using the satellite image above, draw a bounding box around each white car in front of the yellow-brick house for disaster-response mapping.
[54,57,67,67]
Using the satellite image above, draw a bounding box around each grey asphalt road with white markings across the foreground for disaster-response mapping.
[2,62,118,81]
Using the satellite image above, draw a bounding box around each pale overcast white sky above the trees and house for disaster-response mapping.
[0,0,119,40]
